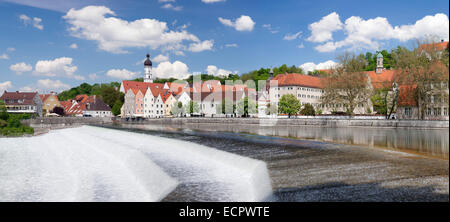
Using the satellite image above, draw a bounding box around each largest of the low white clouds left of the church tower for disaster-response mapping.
[33,57,84,80]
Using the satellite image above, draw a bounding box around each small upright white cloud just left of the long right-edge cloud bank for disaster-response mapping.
[307,12,342,42]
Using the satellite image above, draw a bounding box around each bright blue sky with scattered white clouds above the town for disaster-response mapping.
[0,0,449,93]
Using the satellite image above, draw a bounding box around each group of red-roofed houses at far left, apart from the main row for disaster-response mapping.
[0,91,113,117]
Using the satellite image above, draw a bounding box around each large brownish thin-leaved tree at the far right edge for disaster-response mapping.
[394,42,449,119]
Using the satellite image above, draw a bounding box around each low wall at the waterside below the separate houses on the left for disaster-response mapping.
[21,117,112,129]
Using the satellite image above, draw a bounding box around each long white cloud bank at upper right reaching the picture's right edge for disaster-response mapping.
[308,13,449,52]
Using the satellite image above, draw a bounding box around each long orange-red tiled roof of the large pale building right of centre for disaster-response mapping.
[272,73,323,89]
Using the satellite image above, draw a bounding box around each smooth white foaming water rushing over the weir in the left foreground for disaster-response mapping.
[0,126,272,201]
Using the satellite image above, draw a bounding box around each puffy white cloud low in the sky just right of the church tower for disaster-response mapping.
[153,61,190,79]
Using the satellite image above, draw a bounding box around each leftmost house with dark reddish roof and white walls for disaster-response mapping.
[0,91,42,116]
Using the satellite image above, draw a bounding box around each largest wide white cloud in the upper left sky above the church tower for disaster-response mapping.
[63,6,207,53]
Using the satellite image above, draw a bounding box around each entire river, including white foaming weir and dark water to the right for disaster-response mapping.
[0,124,449,201]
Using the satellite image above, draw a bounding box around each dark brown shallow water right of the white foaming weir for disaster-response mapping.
[99,124,449,202]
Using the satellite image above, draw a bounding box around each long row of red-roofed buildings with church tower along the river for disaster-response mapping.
[120,45,449,120]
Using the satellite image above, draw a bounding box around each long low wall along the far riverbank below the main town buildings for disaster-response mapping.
[125,118,449,128]
